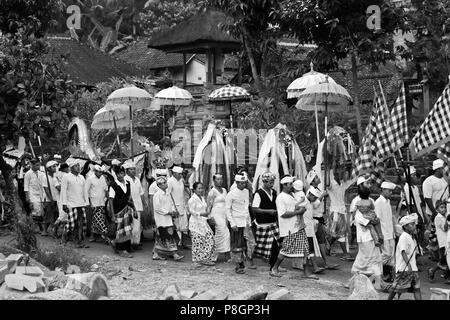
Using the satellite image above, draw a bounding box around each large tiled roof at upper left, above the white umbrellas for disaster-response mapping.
[47,36,143,85]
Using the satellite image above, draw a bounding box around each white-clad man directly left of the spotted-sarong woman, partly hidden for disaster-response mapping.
[167,167,189,249]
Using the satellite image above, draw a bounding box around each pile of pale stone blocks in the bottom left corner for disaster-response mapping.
[0,253,109,300]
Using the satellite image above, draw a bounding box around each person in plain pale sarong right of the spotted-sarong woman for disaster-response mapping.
[207,174,231,260]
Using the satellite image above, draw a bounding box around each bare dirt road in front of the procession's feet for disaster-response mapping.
[0,230,450,300]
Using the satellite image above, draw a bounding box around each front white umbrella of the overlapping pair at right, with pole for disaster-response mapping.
[296,76,353,187]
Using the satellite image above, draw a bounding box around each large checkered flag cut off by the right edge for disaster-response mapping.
[409,85,450,159]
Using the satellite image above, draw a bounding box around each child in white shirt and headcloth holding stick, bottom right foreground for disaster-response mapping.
[388,214,422,300]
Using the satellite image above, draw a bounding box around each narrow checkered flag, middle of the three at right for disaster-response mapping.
[387,83,409,154]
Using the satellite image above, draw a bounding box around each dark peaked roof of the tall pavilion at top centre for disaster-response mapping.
[149,10,240,49]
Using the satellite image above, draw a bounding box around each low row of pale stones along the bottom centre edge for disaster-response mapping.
[158,284,294,300]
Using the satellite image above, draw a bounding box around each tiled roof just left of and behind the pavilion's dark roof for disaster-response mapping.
[114,38,192,71]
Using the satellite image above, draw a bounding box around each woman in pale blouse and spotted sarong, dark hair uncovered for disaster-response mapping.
[188,182,214,266]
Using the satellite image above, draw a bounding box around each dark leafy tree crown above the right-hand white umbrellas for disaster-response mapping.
[278,0,404,70]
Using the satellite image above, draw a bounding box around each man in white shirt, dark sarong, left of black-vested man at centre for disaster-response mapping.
[225,174,256,274]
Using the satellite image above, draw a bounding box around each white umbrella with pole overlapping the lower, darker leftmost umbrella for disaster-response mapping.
[105,86,159,157]
